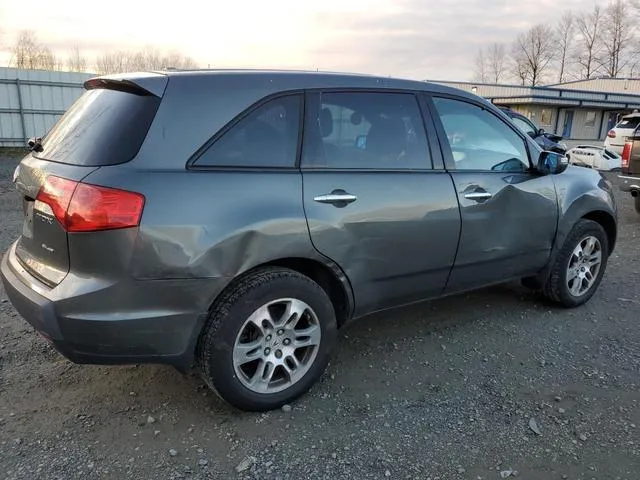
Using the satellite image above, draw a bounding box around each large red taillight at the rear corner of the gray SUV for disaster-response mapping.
[36,176,144,232]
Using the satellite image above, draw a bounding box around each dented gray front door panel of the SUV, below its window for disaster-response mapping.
[449,172,558,290]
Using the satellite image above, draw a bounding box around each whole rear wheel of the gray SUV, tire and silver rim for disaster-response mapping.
[197,268,336,411]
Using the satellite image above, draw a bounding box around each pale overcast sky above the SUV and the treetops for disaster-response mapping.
[0,0,594,80]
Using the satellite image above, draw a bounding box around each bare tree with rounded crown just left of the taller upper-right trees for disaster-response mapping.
[513,24,555,87]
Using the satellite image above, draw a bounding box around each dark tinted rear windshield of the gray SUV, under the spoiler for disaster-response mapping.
[34,89,160,166]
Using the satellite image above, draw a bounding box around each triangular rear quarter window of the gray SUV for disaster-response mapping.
[195,95,301,167]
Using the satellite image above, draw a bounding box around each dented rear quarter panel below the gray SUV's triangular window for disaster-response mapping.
[81,166,326,295]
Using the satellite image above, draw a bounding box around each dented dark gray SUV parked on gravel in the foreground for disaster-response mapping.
[2,71,616,410]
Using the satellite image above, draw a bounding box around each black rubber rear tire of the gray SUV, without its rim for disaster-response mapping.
[196,267,337,411]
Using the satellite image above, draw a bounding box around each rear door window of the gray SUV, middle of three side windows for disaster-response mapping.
[302,92,432,169]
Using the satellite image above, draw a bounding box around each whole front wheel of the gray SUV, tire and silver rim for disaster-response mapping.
[542,219,609,307]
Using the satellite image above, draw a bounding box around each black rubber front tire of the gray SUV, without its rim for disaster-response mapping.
[542,219,609,308]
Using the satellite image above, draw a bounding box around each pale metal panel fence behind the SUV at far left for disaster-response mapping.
[0,68,95,147]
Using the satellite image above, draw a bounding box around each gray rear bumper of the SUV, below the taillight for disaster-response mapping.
[0,242,226,370]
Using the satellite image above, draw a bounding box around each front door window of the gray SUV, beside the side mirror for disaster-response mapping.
[433,98,529,172]
